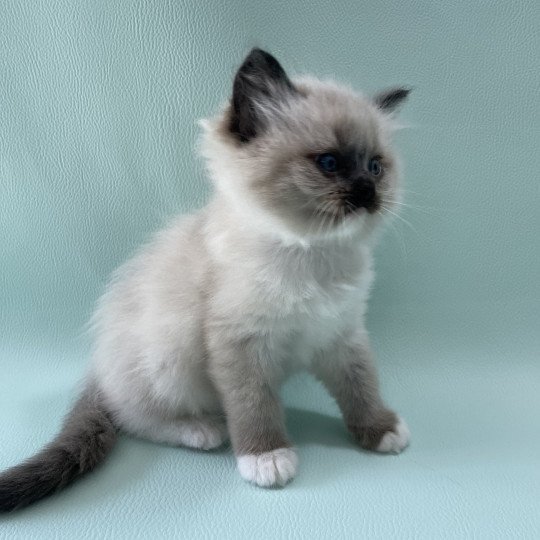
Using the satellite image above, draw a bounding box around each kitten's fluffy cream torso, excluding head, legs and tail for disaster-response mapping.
[91,197,372,443]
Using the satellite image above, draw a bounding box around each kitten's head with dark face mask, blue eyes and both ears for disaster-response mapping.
[202,49,409,243]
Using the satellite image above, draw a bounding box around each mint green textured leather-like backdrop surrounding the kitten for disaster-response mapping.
[0,0,540,538]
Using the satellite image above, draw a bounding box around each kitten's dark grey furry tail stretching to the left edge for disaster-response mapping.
[0,385,116,513]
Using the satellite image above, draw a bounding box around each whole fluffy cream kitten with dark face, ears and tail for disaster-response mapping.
[0,49,409,511]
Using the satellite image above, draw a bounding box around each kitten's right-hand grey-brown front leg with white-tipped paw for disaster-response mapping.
[313,332,409,453]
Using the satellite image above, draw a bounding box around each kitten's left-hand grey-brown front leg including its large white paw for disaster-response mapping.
[210,340,298,487]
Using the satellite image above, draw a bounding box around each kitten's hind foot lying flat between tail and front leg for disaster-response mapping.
[126,416,228,450]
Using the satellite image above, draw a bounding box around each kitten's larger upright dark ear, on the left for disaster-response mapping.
[229,49,297,142]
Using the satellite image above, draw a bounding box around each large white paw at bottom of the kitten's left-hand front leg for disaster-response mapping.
[237,448,298,487]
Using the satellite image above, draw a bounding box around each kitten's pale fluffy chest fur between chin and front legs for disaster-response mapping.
[209,226,372,370]
